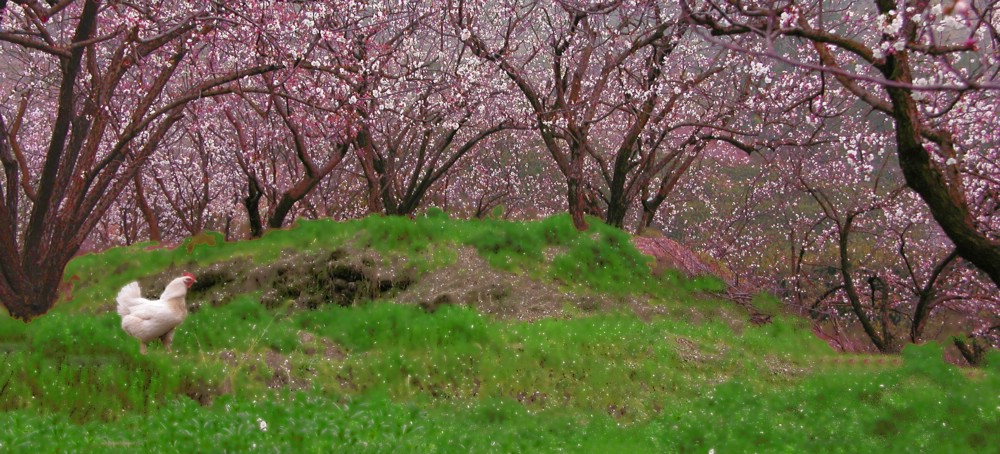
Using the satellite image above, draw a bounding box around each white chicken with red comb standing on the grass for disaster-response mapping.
[117,273,197,355]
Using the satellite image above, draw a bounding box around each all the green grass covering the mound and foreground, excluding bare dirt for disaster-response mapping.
[0,214,1000,452]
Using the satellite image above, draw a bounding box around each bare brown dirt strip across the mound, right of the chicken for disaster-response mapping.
[141,246,657,321]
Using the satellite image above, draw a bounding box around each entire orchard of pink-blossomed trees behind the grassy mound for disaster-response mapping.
[0,0,1000,362]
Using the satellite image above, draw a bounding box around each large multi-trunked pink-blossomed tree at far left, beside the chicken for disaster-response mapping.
[0,0,320,320]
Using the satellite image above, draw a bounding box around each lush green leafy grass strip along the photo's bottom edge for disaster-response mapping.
[0,345,1000,452]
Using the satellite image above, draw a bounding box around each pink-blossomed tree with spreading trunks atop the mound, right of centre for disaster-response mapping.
[447,0,752,229]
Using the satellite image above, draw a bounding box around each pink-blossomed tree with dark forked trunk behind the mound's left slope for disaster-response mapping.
[152,2,359,237]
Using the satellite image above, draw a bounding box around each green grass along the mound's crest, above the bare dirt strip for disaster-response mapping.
[61,215,722,310]
